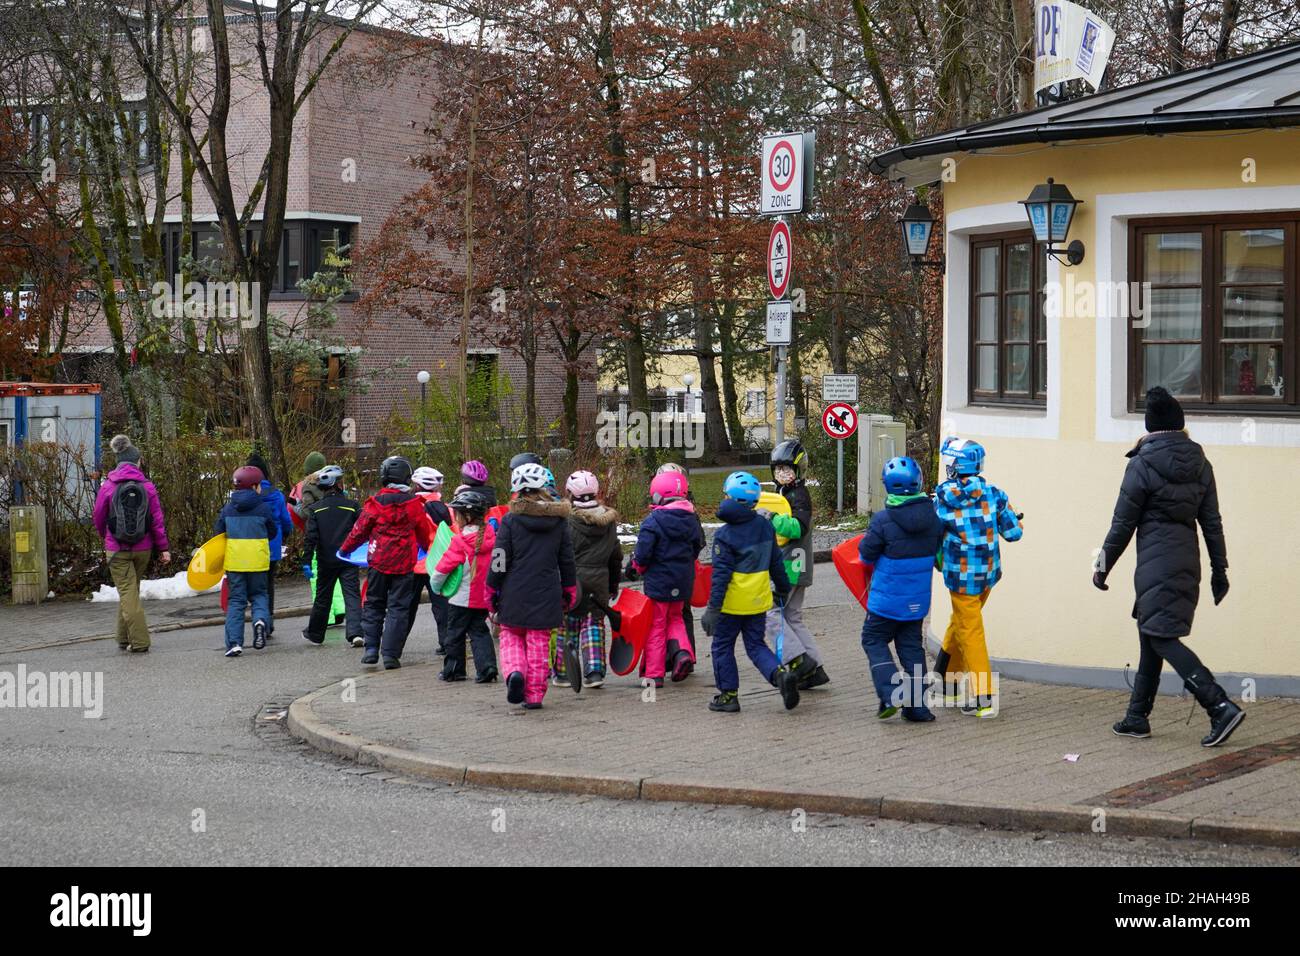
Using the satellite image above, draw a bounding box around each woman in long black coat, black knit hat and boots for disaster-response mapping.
[1092,386,1245,747]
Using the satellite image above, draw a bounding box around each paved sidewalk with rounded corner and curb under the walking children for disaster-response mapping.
[290,606,1300,847]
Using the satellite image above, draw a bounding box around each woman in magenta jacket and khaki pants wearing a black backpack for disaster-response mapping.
[94,434,172,653]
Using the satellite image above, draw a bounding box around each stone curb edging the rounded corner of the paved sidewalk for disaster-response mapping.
[285,684,1300,849]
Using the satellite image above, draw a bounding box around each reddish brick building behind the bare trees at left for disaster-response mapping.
[52,4,595,446]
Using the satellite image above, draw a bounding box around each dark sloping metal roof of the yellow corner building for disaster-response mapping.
[868,42,1300,186]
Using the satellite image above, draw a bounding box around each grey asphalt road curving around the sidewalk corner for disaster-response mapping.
[0,567,1296,866]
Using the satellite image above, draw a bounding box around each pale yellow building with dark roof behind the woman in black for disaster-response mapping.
[872,44,1300,696]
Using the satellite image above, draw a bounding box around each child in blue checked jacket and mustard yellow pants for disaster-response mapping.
[935,438,1023,717]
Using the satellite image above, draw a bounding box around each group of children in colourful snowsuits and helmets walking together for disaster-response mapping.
[217,440,1021,721]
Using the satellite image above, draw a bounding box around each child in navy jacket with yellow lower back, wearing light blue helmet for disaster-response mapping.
[701,471,800,714]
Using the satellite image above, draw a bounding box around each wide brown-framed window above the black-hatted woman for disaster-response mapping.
[1128,213,1300,411]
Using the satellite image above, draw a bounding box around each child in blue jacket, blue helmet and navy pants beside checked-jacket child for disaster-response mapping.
[858,457,944,723]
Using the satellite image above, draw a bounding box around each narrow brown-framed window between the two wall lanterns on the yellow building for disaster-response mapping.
[970,232,1048,405]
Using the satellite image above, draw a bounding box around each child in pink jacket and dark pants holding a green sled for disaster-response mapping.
[429,488,497,684]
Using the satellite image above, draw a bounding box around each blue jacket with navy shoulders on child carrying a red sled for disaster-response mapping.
[858,494,944,620]
